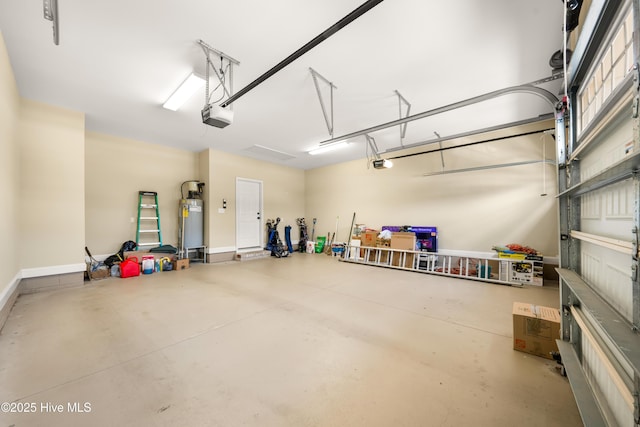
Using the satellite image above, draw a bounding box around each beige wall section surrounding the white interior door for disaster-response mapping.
[207,150,305,251]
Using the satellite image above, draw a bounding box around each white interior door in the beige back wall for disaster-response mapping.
[236,178,262,249]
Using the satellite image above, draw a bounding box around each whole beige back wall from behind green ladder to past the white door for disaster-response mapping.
[85,144,304,255]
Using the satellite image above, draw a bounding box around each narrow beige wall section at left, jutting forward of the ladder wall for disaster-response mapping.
[18,100,85,268]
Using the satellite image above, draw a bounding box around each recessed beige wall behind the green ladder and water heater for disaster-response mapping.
[84,132,200,255]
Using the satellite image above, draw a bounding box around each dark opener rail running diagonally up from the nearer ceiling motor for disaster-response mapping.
[220,0,383,107]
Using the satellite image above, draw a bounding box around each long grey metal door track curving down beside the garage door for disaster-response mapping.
[320,84,559,147]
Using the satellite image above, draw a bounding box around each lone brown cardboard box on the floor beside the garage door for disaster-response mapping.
[513,302,560,359]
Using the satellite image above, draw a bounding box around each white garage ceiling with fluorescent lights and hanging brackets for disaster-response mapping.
[0,0,563,169]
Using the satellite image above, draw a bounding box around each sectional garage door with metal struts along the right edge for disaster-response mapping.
[558,1,640,426]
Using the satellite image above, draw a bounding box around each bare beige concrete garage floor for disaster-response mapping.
[0,254,582,427]
